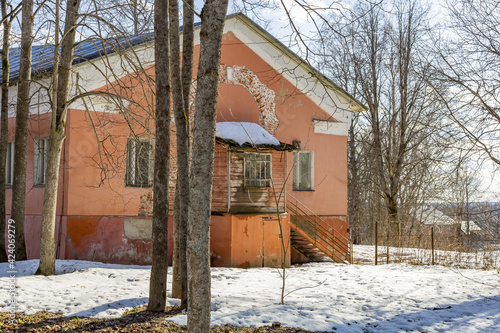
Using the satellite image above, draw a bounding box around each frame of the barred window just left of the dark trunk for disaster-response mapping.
[125,137,154,188]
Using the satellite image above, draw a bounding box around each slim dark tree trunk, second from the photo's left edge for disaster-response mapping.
[11,0,33,260]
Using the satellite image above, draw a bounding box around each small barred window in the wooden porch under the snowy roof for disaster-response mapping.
[245,153,271,187]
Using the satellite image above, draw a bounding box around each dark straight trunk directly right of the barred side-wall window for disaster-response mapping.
[148,0,170,312]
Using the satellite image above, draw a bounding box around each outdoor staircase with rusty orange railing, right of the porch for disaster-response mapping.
[286,193,350,264]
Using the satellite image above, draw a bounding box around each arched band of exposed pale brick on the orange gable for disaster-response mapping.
[190,65,279,135]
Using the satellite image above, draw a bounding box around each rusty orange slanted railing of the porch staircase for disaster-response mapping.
[286,193,350,263]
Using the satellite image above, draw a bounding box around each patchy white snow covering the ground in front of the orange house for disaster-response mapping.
[0,247,500,332]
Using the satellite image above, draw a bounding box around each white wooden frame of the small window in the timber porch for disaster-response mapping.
[243,153,273,188]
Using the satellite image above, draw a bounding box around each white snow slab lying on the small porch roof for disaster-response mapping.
[215,122,280,146]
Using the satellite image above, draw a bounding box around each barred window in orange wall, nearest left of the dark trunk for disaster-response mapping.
[126,138,153,187]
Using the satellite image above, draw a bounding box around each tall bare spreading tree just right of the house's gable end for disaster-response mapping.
[324,0,450,245]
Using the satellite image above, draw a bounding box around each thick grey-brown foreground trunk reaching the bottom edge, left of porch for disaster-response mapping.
[187,0,228,333]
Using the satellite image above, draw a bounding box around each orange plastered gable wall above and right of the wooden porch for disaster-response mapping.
[218,32,347,215]
